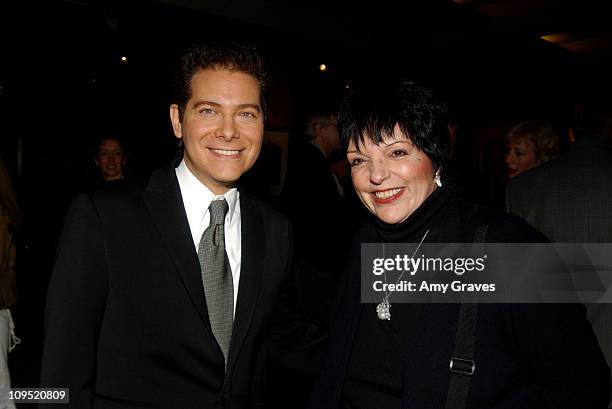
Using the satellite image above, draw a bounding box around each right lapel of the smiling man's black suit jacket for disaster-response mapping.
[228,190,266,369]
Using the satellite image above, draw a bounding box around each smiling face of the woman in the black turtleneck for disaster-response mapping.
[347,125,436,224]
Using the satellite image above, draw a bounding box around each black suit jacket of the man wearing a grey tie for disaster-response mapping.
[41,161,306,409]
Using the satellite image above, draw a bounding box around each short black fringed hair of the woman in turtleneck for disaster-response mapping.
[338,78,450,171]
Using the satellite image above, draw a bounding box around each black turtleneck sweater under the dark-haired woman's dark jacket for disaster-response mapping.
[342,188,452,409]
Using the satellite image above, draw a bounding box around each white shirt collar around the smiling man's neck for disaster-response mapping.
[176,159,238,223]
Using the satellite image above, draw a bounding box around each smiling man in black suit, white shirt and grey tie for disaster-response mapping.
[41,44,318,409]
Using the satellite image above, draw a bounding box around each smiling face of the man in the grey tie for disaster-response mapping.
[170,69,264,195]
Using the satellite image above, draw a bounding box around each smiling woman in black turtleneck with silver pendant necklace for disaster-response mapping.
[309,79,610,409]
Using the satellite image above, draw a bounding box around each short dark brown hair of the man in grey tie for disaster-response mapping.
[173,42,268,119]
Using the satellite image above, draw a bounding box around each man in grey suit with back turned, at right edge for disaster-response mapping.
[506,103,612,403]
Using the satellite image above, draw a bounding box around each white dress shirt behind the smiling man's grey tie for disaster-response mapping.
[175,159,242,315]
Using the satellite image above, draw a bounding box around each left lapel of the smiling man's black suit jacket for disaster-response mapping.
[144,161,212,335]
